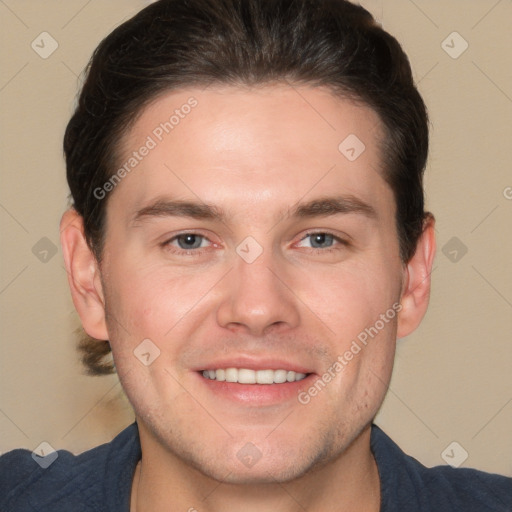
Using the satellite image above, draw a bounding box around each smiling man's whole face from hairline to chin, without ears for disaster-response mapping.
[96,85,404,482]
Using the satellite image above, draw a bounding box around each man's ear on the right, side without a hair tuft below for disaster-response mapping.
[397,213,436,338]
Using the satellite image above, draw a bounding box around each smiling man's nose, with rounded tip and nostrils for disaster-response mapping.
[217,253,300,336]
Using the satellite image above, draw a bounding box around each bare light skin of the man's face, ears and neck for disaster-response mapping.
[62,84,435,512]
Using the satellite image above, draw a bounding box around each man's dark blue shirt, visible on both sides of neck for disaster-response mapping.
[0,423,512,512]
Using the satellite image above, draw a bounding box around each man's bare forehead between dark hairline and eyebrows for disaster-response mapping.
[112,84,391,219]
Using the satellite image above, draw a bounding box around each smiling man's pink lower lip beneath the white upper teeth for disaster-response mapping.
[197,373,314,405]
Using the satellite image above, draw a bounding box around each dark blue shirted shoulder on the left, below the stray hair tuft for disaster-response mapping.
[0,424,140,512]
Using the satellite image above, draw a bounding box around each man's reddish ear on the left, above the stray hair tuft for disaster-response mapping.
[60,209,108,340]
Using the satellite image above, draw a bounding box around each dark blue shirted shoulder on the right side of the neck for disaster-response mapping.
[372,425,512,512]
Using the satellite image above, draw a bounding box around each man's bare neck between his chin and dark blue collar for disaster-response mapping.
[130,426,380,512]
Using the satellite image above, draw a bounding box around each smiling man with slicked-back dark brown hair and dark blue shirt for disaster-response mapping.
[0,0,512,512]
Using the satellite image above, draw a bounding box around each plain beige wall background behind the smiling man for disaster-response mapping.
[0,0,512,475]
